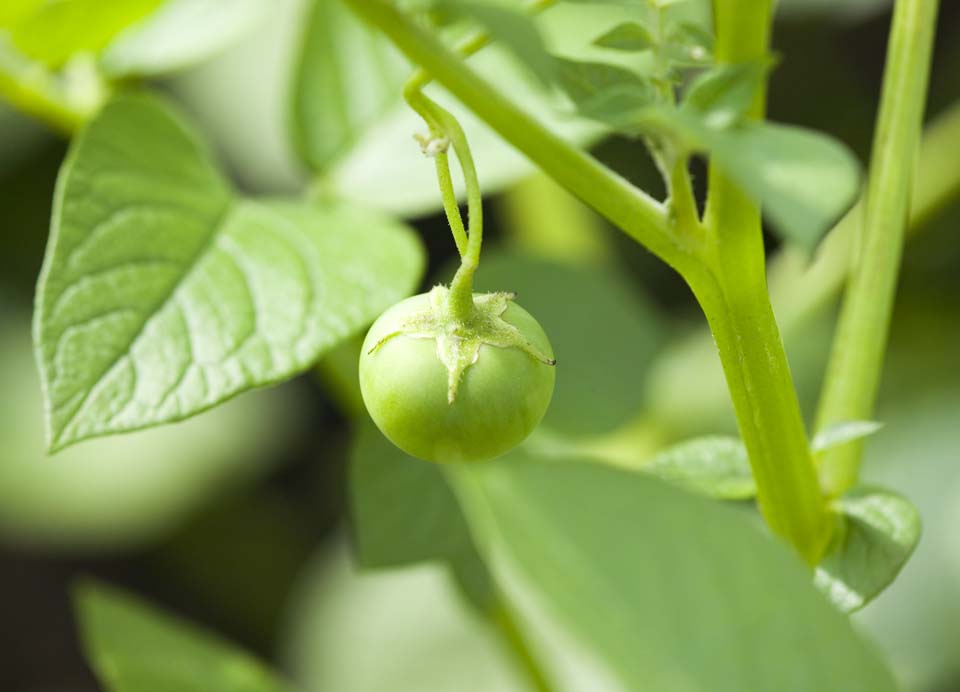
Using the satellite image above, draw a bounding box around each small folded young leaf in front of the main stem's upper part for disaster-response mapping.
[681,63,767,129]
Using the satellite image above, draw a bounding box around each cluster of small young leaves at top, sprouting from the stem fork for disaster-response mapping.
[442,0,860,250]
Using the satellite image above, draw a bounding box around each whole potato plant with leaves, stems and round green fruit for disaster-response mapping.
[0,0,960,692]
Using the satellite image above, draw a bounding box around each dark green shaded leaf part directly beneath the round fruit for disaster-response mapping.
[350,424,490,605]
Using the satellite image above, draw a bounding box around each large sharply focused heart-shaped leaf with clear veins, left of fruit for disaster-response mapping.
[34,95,423,450]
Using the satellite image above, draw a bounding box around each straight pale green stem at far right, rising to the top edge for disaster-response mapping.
[817,0,937,495]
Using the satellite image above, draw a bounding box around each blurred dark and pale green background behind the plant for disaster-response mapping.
[0,0,960,692]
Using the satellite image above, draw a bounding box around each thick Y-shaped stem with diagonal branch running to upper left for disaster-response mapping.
[346,0,829,563]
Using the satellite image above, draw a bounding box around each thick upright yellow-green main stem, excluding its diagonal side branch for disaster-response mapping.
[692,0,830,563]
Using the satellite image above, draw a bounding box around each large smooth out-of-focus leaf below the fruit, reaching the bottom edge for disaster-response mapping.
[457,455,896,692]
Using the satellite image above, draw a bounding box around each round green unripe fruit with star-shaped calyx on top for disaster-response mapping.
[360,286,556,463]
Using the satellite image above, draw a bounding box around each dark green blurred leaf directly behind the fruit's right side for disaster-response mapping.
[468,248,664,435]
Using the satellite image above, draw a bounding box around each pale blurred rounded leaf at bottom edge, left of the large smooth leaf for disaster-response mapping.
[283,541,529,692]
